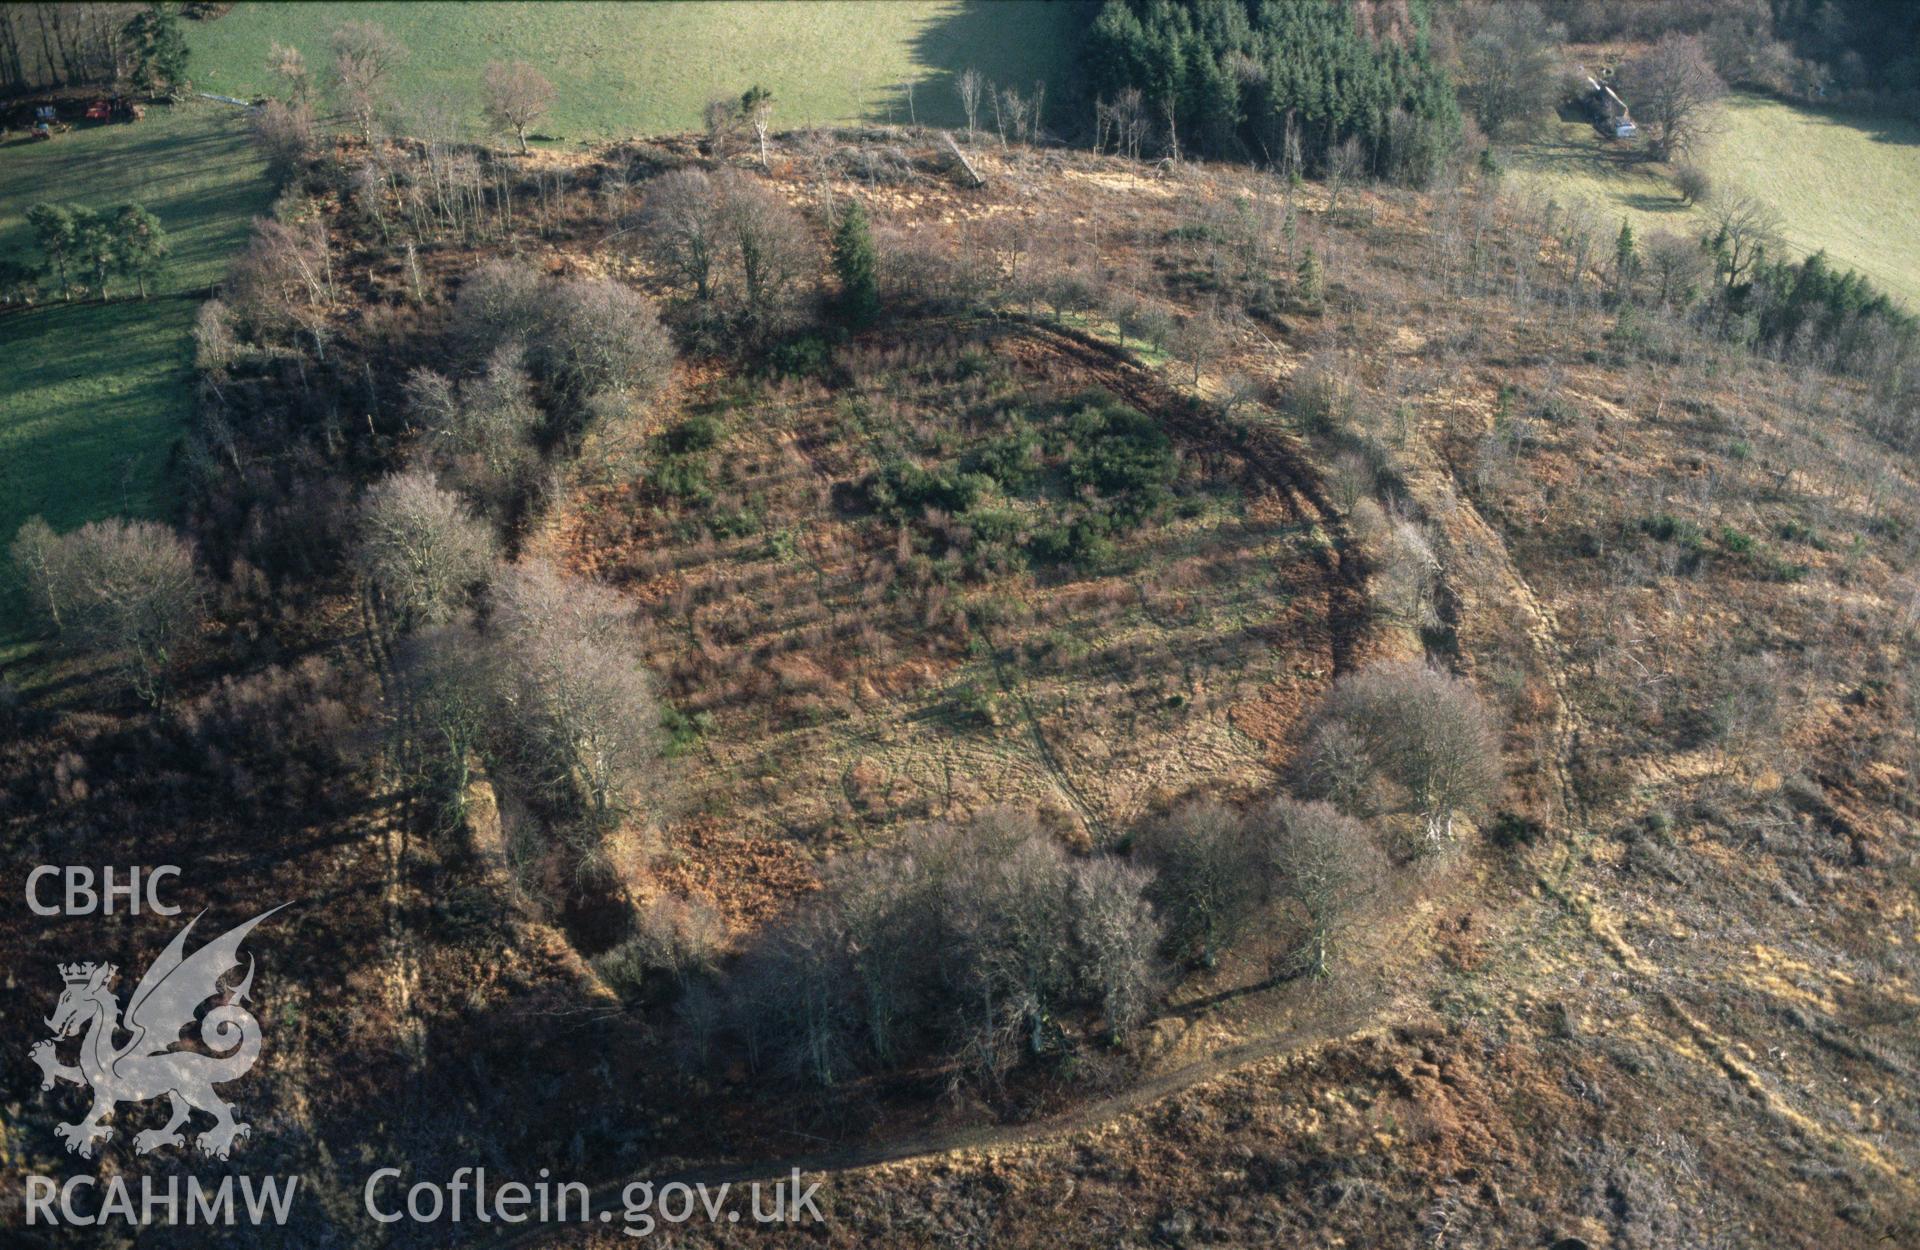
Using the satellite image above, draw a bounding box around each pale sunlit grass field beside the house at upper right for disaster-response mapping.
[1507,94,1920,309]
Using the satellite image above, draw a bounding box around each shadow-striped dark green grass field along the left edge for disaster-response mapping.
[0,104,271,655]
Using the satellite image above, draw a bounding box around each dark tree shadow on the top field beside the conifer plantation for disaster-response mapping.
[868,0,1100,132]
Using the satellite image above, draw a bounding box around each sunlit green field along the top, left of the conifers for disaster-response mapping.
[186,0,1092,142]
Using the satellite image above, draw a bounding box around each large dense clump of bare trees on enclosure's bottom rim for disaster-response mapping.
[733,808,1160,1085]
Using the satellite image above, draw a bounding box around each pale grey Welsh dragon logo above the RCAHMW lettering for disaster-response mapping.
[29,902,286,1158]
